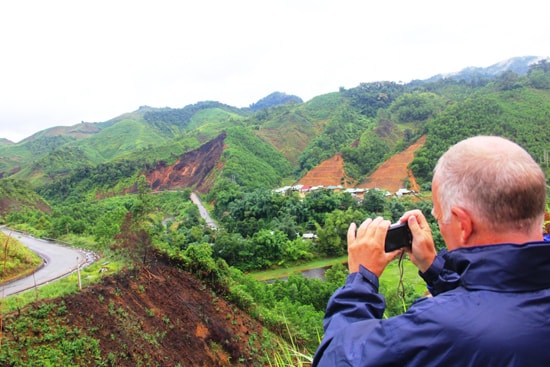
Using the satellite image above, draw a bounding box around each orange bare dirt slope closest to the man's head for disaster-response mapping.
[358,136,426,193]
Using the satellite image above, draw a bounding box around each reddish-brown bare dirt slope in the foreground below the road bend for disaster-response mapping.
[3,264,270,367]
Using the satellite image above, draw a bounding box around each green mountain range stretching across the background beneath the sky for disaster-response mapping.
[0,56,550,198]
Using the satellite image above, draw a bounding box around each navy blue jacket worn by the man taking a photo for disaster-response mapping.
[313,242,550,367]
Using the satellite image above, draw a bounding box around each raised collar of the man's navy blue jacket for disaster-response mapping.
[443,242,550,292]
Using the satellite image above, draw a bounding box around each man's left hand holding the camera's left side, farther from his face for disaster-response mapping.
[348,217,401,277]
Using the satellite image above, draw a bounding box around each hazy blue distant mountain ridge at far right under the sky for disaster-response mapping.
[423,56,548,82]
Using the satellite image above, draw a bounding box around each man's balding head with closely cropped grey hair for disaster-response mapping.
[433,136,546,247]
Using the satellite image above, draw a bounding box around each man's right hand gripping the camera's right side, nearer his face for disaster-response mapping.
[399,209,437,273]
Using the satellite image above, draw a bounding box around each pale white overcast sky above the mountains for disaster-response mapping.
[0,0,550,142]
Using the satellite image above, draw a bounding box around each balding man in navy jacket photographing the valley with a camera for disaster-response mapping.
[313,136,550,367]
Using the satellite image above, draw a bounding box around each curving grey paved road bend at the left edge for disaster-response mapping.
[0,228,95,296]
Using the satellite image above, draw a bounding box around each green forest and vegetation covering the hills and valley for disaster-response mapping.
[0,61,550,366]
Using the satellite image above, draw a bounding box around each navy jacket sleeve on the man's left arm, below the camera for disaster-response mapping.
[312,266,386,367]
